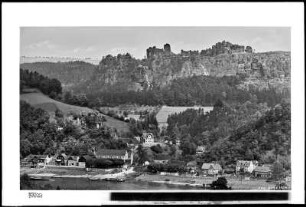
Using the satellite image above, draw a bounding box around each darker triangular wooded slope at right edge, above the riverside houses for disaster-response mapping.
[203,102,291,169]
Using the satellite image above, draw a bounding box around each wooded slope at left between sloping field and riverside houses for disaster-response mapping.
[20,101,126,157]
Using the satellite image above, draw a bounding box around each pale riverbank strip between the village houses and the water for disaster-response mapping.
[20,167,291,190]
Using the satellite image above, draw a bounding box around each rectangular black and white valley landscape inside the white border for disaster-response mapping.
[2,4,305,205]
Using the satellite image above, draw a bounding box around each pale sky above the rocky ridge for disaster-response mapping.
[20,27,291,58]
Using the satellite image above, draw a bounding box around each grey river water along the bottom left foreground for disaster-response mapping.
[33,178,203,190]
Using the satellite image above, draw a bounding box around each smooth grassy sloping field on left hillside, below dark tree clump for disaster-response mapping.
[20,92,130,133]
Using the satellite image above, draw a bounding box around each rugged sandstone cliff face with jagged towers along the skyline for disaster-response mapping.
[92,42,291,90]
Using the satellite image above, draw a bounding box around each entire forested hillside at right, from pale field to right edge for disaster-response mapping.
[166,99,291,168]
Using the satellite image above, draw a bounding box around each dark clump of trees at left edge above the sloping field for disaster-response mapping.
[20,69,62,98]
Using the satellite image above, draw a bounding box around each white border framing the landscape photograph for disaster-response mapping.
[2,2,305,205]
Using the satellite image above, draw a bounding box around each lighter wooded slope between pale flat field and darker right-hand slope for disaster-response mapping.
[166,96,269,150]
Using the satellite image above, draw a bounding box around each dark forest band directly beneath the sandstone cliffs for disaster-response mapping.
[75,76,290,107]
